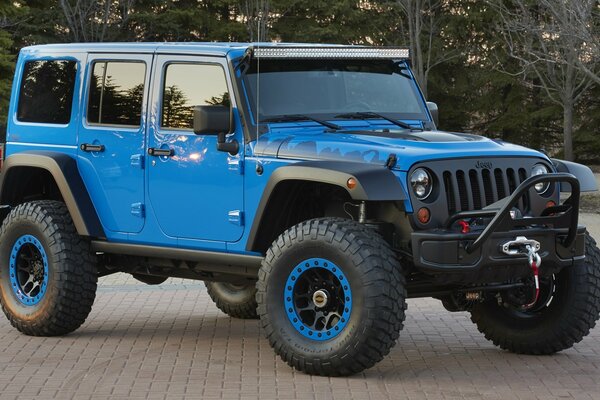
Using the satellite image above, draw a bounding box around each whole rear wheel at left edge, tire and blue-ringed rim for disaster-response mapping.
[0,201,98,336]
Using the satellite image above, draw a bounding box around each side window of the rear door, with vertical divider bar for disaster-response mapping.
[87,61,146,126]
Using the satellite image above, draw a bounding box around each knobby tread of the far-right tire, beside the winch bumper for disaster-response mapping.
[471,233,600,355]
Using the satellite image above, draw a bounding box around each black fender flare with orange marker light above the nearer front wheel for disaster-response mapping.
[246,161,408,250]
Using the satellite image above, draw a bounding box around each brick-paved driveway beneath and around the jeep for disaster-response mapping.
[0,215,600,400]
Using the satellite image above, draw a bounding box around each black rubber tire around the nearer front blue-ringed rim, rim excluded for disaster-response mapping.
[256,218,406,376]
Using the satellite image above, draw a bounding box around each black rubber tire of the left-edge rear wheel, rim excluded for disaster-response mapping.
[0,200,98,336]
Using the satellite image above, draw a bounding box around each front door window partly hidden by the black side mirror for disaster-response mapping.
[161,64,230,129]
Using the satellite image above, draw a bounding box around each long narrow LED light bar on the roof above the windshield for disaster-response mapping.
[251,46,410,59]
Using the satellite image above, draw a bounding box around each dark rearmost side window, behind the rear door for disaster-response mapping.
[17,60,77,124]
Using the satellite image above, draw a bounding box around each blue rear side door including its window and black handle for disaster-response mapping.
[77,54,152,236]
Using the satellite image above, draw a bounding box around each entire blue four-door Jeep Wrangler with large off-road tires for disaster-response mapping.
[0,43,600,375]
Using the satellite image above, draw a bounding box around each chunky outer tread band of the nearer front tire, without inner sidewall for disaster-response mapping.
[256,218,407,376]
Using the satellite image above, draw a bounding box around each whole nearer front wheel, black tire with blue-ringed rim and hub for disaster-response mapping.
[256,218,406,376]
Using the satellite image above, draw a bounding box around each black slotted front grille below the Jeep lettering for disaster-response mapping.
[442,168,529,215]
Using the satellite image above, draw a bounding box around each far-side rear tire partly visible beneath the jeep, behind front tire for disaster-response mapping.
[204,282,258,319]
